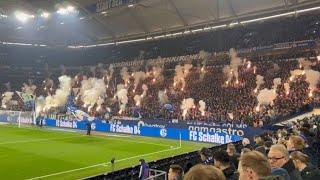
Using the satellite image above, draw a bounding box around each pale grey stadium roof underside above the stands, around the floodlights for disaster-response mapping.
[0,0,320,45]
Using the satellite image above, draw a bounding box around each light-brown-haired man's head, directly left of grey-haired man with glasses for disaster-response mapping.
[238,151,271,180]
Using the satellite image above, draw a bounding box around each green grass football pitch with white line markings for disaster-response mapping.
[0,125,213,180]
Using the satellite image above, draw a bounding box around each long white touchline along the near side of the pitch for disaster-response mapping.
[26,147,181,180]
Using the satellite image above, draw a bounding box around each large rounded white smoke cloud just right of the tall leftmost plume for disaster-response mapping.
[81,78,106,108]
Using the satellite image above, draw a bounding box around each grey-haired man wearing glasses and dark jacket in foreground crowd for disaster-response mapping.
[268,144,301,180]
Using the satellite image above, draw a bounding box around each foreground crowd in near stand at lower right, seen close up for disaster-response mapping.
[139,116,320,180]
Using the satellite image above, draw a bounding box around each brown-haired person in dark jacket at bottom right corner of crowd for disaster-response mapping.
[290,151,320,180]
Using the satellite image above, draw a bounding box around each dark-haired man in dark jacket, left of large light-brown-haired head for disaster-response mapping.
[213,150,238,180]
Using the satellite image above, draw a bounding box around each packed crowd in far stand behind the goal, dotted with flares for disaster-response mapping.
[1,52,320,126]
